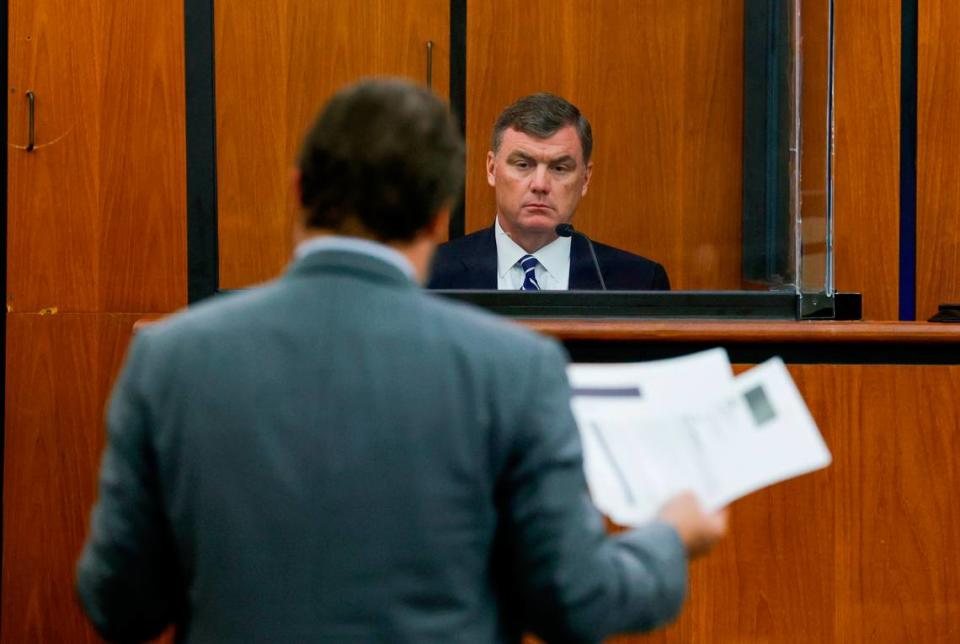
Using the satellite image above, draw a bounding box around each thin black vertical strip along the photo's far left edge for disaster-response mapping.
[0,0,10,620]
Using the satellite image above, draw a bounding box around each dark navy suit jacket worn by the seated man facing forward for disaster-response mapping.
[427,226,670,291]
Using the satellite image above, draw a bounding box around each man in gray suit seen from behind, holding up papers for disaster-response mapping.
[77,80,724,642]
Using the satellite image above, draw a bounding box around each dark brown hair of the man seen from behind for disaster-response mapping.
[298,79,464,242]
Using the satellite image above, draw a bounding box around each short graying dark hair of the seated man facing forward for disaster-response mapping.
[491,92,593,163]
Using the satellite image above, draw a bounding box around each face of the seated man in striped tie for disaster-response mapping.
[487,125,592,247]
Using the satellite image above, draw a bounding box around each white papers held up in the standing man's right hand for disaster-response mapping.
[568,349,830,525]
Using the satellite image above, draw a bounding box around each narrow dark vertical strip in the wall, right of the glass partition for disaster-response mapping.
[899,0,918,320]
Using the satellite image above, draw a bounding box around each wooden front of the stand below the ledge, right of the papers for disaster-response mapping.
[624,365,960,644]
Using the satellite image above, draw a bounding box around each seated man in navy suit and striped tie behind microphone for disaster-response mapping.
[428,94,670,291]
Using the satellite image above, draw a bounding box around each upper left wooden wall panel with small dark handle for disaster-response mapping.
[7,0,186,312]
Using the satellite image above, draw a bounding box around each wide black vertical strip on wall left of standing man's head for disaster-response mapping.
[183,0,220,303]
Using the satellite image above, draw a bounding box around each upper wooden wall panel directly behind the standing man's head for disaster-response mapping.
[215,0,450,288]
